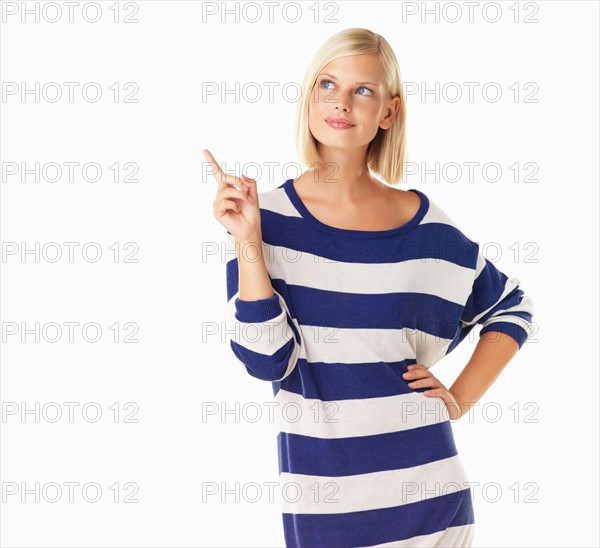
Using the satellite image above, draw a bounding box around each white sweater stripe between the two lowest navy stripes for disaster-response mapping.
[280,455,470,514]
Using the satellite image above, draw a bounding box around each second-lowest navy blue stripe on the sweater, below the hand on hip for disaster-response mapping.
[277,422,457,477]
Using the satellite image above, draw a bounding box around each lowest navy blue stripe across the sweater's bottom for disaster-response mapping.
[283,486,475,548]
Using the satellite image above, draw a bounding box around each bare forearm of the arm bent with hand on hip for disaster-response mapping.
[450,331,519,417]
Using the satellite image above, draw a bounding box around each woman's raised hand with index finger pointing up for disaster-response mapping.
[203,149,262,242]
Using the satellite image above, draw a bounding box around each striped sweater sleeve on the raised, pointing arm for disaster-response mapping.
[226,231,301,382]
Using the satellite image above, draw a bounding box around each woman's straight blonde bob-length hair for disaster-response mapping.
[296,28,406,185]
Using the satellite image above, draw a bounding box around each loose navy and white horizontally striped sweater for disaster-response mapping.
[226,179,533,547]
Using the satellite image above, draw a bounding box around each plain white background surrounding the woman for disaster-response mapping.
[0,0,599,547]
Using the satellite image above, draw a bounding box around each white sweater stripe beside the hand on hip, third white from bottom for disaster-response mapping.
[274,388,449,439]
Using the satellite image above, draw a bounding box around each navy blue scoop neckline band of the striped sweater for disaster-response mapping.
[283,179,429,239]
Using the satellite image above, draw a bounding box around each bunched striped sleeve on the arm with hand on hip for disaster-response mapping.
[461,244,534,349]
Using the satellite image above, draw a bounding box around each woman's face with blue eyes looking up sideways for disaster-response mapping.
[308,54,400,148]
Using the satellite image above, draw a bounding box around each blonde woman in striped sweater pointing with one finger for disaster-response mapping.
[205,29,533,547]
